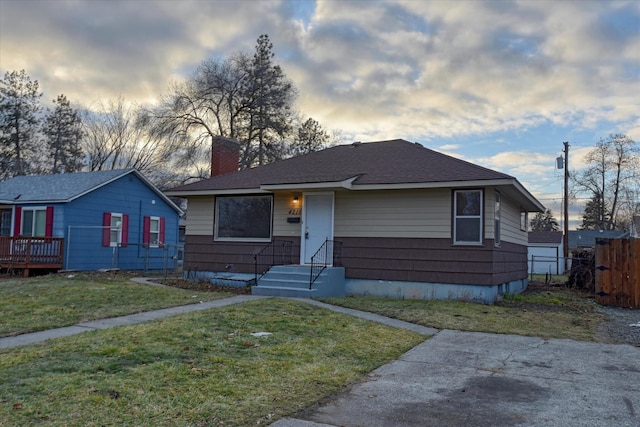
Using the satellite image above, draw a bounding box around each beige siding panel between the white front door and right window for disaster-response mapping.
[334,189,451,239]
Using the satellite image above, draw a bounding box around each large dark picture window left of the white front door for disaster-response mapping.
[215,196,273,241]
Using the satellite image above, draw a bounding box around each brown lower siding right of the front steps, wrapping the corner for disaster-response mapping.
[336,237,527,286]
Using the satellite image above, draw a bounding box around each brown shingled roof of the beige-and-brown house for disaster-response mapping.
[171,139,513,192]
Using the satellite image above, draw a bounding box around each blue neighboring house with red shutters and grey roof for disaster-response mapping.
[0,169,182,270]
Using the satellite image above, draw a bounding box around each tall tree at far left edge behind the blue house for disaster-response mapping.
[0,70,42,179]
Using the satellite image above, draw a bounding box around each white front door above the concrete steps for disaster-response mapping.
[300,193,333,264]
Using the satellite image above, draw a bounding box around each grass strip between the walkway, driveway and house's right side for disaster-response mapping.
[323,286,603,341]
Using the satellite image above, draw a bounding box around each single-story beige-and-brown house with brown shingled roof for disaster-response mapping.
[166,139,544,302]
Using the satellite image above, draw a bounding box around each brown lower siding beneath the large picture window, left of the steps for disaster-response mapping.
[184,235,300,273]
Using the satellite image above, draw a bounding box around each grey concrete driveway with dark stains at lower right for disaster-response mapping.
[272,330,640,427]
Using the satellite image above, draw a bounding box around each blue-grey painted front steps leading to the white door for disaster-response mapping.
[251,265,345,298]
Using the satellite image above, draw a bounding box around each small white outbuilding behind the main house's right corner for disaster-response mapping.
[529,231,565,274]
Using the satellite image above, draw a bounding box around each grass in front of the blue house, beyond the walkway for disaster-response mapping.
[0,273,229,337]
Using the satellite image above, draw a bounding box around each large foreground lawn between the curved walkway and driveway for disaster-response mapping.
[0,299,424,426]
